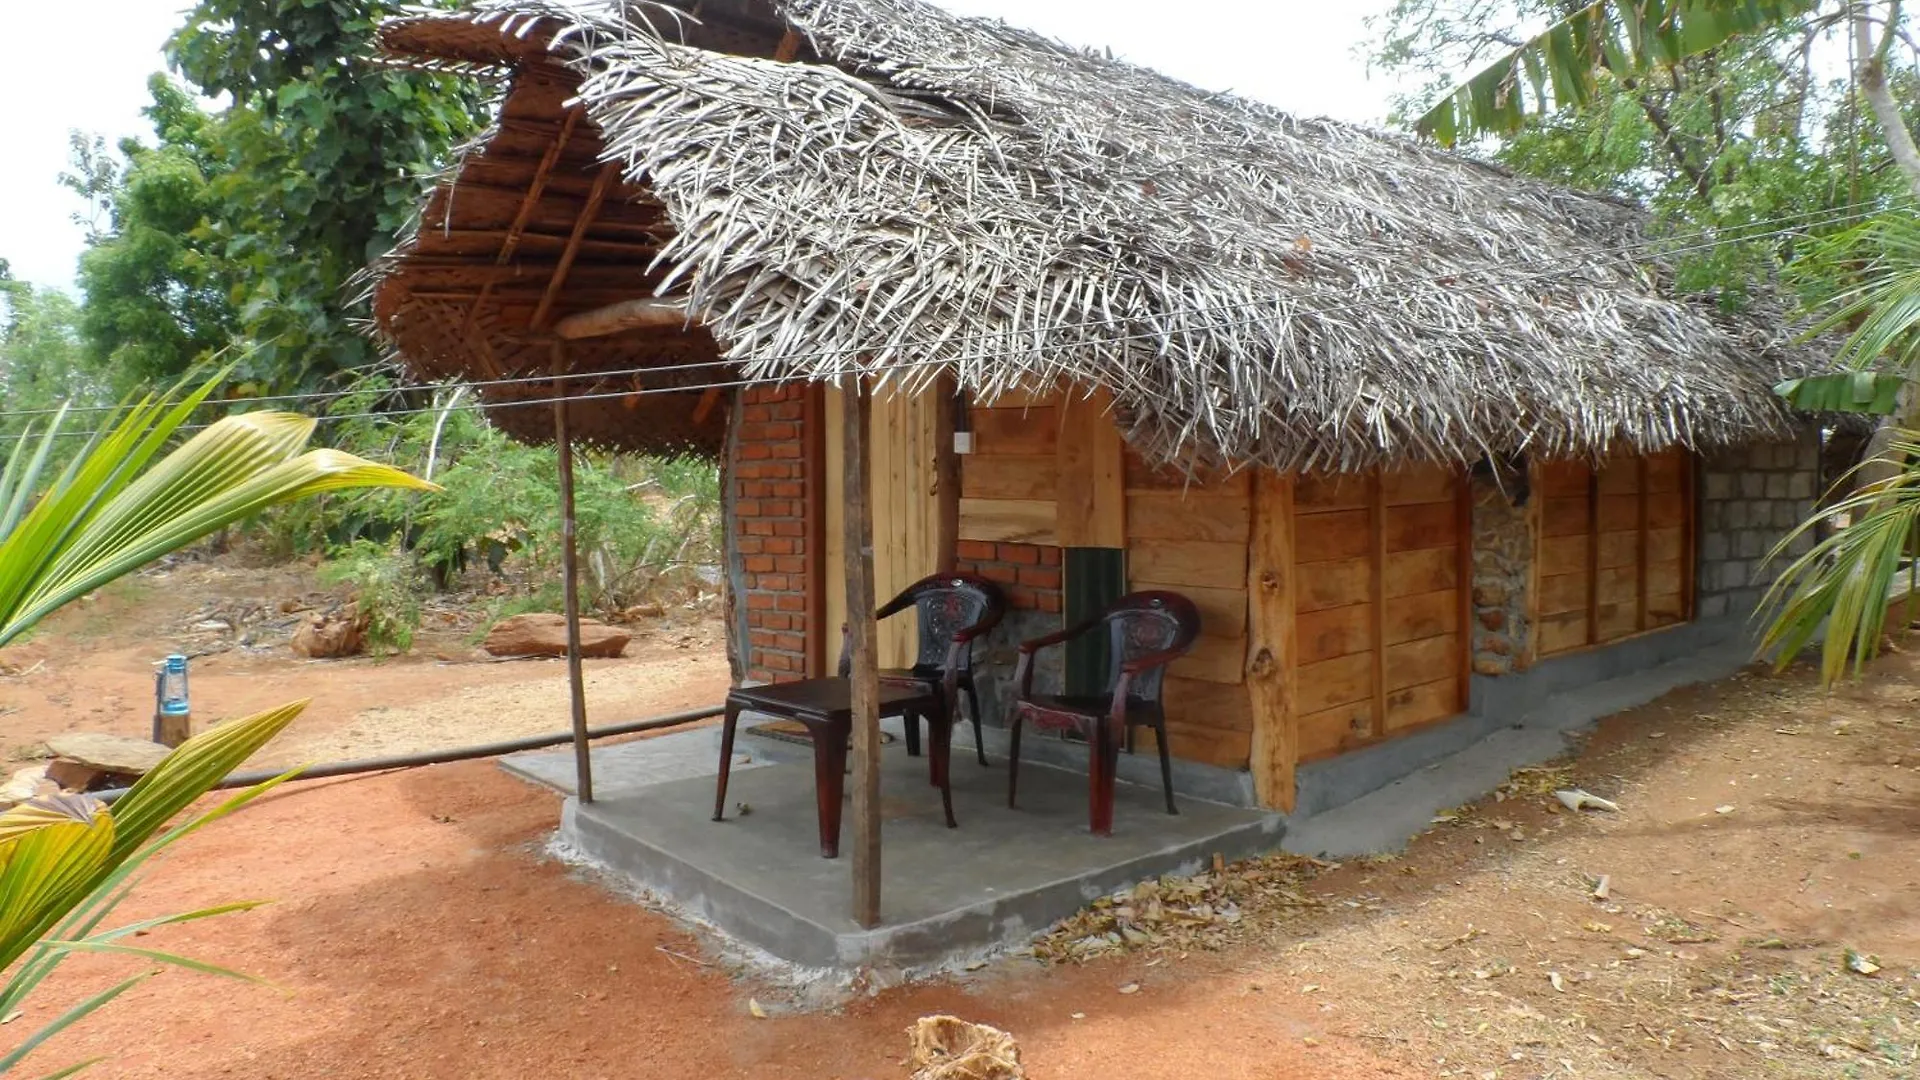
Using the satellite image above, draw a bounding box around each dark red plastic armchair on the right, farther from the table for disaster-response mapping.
[1006,592,1200,836]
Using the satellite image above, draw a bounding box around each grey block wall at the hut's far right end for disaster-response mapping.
[1693,427,1820,619]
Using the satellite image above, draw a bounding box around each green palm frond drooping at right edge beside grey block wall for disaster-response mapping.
[1759,430,1920,684]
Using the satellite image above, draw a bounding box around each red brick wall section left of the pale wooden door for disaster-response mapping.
[730,386,810,682]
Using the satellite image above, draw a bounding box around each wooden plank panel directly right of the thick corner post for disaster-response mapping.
[1294,467,1471,761]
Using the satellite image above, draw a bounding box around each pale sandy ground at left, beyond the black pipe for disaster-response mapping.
[0,563,728,767]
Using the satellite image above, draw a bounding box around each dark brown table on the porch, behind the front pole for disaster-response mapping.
[714,676,958,859]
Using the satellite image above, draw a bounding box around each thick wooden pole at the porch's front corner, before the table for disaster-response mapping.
[841,382,879,926]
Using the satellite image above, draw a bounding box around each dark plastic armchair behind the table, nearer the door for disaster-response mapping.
[839,573,1006,765]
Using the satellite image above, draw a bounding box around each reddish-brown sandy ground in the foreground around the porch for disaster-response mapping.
[0,557,1920,1080]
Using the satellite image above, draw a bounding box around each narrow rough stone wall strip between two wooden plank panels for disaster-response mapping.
[1471,473,1534,675]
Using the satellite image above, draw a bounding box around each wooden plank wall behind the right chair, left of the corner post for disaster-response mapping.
[1127,452,1254,769]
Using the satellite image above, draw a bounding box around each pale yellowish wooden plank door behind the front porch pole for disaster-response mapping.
[822,388,947,667]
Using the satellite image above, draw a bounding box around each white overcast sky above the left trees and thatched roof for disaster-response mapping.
[0,0,1388,288]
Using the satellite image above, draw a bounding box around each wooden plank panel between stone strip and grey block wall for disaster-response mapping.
[1534,450,1692,655]
